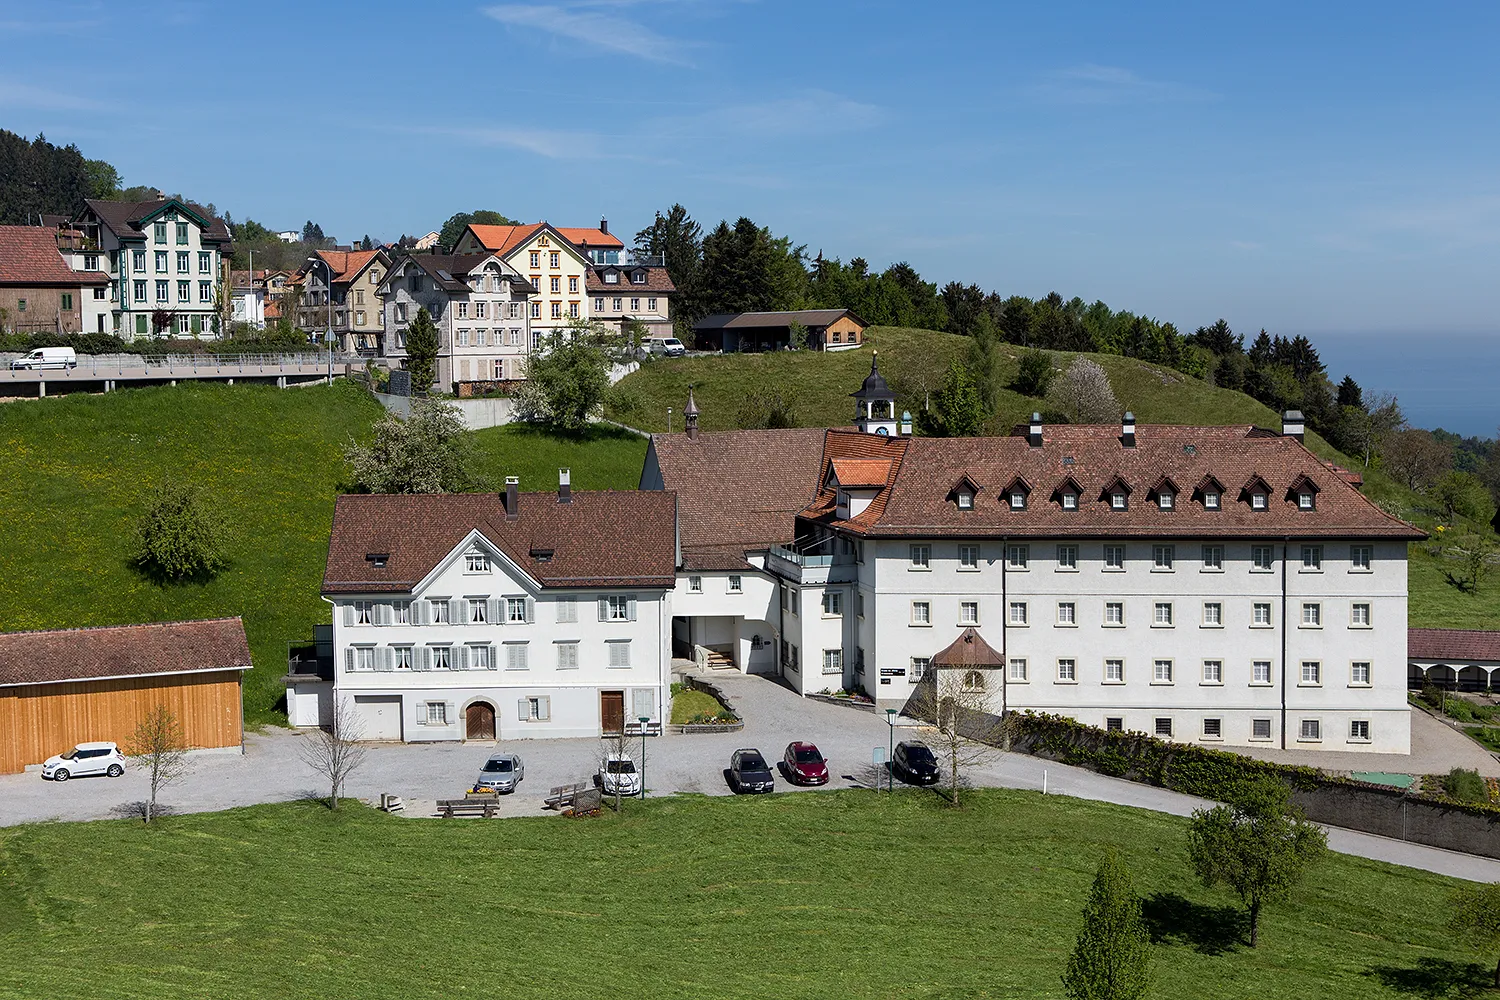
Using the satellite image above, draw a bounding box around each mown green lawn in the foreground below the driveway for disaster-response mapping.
[0,790,1488,1000]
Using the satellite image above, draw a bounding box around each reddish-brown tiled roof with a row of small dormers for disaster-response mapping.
[807,424,1425,540]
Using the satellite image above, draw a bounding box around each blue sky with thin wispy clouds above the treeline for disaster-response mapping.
[0,0,1500,352]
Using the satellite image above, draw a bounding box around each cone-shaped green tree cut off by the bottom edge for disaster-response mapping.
[1062,851,1152,1000]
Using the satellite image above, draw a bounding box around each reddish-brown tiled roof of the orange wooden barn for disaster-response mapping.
[0,618,251,687]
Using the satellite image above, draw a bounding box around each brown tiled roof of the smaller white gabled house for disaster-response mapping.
[331,490,677,594]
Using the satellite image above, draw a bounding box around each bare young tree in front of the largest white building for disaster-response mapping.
[908,666,1005,808]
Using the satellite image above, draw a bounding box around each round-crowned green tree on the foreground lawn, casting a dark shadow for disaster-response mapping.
[1188,778,1328,948]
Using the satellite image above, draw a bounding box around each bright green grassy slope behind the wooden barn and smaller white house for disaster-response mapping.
[0,382,645,724]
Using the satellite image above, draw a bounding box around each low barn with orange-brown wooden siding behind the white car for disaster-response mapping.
[0,618,251,774]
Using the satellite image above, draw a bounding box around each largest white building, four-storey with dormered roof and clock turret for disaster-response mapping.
[641,359,1424,753]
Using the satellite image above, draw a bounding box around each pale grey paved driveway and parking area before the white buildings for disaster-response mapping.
[0,672,1500,882]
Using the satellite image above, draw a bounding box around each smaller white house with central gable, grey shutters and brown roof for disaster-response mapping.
[313,469,677,742]
